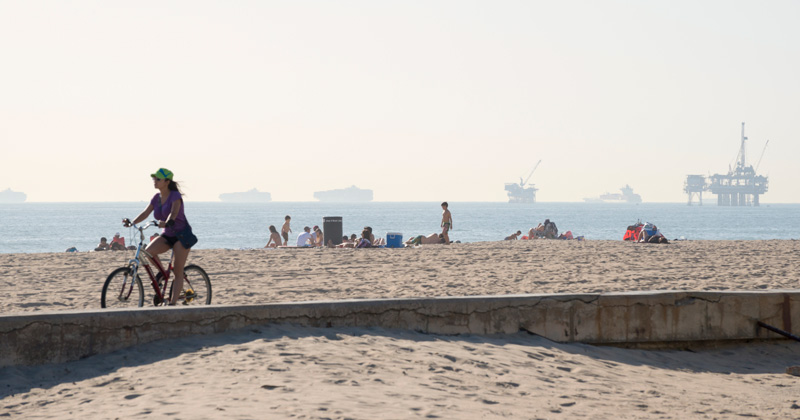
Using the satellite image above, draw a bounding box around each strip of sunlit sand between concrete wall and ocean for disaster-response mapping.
[0,240,800,315]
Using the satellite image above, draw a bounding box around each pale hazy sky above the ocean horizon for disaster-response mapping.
[0,0,800,203]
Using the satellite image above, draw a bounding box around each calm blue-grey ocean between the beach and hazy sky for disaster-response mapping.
[0,202,800,253]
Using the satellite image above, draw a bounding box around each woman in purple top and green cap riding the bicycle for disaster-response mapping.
[122,168,197,305]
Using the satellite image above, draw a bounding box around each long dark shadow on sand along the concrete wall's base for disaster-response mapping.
[0,325,800,399]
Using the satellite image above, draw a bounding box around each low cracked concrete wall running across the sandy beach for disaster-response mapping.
[0,290,800,367]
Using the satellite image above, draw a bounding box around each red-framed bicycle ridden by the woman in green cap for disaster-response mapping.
[100,220,211,308]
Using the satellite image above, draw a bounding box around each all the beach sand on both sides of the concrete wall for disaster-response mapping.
[0,241,800,419]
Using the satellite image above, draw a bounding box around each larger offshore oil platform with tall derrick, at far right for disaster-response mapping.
[683,123,769,206]
